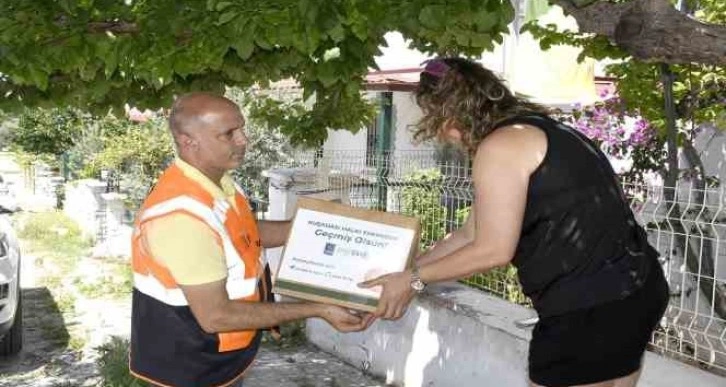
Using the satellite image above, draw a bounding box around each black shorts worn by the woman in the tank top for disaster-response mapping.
[529,260,668,387]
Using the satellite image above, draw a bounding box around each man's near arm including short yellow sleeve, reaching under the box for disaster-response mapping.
[144,214,370,332]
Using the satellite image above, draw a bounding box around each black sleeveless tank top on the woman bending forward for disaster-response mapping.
[498,115,658,317]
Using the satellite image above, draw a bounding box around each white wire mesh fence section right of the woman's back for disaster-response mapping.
[624,182,726,374]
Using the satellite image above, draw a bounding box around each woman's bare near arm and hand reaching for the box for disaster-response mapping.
[364,125,547,319]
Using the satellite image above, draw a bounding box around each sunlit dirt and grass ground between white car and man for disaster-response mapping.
[0,215,131,387]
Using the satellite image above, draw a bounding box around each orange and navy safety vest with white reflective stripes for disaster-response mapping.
[129,165,272,387]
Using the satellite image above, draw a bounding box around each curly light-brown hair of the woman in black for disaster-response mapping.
[414,58,548,155]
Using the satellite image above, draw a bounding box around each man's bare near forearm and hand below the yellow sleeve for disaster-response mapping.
[179,280,372,333]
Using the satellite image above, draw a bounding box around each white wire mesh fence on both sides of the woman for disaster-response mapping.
[249,151,726,373]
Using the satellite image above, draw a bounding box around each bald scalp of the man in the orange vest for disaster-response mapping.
[169,92,239,144]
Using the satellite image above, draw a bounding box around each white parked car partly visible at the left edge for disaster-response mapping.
[0,206,23,357]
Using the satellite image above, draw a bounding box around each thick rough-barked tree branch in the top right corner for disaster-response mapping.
[552,0,726,65]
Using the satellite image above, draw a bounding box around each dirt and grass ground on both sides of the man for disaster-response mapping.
[0,212,384,387]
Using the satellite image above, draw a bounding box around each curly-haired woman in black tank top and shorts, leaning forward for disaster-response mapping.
[361,58,668,387]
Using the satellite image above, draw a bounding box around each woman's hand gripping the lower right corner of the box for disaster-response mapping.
[358,270,415,320]
